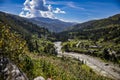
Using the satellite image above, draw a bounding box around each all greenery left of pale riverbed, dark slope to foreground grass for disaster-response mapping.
[0,13,111,80]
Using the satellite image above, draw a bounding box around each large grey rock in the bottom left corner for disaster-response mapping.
[0,57,28,80]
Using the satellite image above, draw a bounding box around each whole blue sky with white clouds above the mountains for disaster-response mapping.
[0,0,120,22]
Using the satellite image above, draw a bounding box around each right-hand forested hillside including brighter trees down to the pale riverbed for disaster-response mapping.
[58,14,120,63]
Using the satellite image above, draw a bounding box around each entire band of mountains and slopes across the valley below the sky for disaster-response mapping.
[0,12,120,42]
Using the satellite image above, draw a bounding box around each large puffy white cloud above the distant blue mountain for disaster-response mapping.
[19,0,65,18]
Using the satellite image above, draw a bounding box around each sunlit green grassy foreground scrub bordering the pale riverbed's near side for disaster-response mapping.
[19,53,111,80]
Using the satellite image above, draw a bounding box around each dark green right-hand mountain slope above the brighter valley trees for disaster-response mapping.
[58,14,120,43]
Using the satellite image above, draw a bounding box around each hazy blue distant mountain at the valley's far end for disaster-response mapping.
[28,17,77,32]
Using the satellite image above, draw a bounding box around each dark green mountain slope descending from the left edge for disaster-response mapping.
[0,12,50,37]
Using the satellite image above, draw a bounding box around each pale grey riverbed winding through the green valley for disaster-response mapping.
[54,42,120,80]
